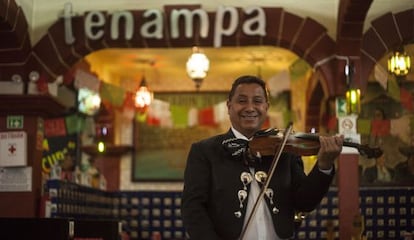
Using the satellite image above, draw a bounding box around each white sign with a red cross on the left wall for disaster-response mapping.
[0,131,27,167]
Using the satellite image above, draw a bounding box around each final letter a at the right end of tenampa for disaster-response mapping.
[243,7,266,37]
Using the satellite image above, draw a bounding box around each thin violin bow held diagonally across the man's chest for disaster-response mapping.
[240,122,293,240]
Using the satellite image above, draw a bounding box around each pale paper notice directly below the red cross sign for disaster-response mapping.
[0,167,32,192]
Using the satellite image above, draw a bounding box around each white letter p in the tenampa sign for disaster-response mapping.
[214,6,239,47]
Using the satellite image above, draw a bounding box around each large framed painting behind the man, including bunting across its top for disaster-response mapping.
[132,92,228,181]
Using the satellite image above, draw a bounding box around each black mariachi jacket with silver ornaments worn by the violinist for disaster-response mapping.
[182,130,333,240]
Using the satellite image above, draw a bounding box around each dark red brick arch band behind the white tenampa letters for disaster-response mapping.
[32,6,335,94]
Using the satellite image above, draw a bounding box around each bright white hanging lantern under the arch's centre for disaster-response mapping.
[186,47,210,90]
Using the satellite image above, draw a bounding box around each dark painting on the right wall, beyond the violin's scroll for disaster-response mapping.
[358,82,414,186]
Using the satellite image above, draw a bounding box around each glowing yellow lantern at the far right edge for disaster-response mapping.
[388,50,411,77]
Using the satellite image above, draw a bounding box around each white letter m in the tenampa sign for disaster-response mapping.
[170,9,209,38]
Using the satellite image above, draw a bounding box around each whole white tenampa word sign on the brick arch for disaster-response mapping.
[62,2,266,47]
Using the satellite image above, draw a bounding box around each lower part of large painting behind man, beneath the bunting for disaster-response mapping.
[133,124,225,181]
